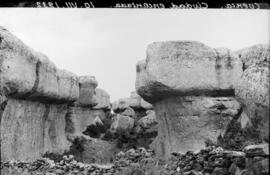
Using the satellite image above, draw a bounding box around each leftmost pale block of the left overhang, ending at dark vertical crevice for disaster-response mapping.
[0,28,38,95]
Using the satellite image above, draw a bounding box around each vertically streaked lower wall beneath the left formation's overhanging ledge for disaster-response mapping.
[1,99,70,161]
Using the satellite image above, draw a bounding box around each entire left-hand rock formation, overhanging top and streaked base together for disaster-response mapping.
[0,28,110,161]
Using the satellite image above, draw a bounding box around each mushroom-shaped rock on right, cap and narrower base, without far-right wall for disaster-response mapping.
[136,41,245,157]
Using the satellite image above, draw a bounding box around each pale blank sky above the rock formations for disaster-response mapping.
[0,8,270,101]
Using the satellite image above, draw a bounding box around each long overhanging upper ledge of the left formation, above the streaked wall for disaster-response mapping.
[0,28,79,102]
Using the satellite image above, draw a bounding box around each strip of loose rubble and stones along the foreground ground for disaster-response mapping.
[1,144,269,175]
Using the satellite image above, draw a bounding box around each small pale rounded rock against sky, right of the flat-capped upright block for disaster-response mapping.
[93,88,111,109]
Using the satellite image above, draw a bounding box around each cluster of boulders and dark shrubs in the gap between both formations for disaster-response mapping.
[110,92,157,148]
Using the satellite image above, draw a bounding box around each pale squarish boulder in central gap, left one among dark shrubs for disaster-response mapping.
[110,114,134,134]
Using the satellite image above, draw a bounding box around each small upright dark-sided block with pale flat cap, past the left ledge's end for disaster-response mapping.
[76,76,98,107]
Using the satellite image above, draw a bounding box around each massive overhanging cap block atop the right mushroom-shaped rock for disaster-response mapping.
[136,41,242,102]
